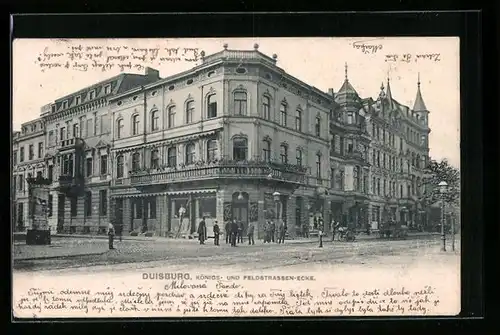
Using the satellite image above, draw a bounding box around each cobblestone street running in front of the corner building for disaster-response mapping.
[14,236,459,274]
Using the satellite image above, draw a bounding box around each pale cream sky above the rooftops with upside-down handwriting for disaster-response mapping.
[13,37,460,168]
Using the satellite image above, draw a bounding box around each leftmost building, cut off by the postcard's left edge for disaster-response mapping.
[12,118,46,231]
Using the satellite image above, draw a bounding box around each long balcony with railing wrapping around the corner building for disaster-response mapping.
[120,161,306,186]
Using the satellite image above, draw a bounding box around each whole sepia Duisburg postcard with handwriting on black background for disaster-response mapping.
[10,37,461,319]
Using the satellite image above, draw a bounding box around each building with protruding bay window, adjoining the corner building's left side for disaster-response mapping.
[41,68,159,233]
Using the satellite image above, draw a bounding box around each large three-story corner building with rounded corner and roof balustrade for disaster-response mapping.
[110,45,331,236]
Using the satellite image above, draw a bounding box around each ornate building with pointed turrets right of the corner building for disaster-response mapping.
[330,70,430,229]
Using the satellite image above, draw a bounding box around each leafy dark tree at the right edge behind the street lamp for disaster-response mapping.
[420,159,460,206]
